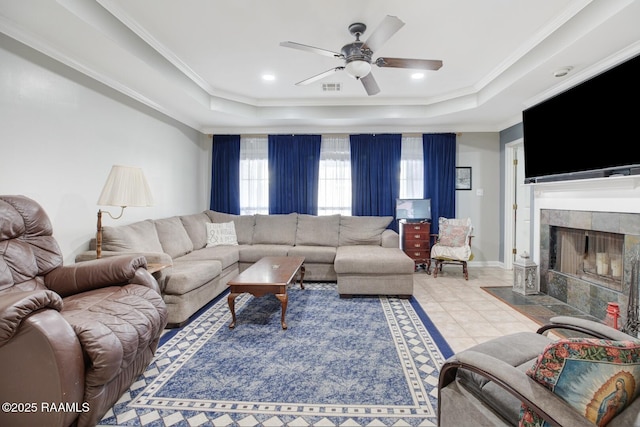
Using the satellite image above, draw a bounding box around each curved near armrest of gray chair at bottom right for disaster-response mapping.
[438,350,593,427]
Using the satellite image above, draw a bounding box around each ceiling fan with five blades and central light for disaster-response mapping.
[280,15,442,96]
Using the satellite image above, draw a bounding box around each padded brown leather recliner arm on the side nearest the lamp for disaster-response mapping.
[44,255,157,298]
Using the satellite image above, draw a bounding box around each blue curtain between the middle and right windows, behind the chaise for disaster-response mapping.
[349,134,402,224]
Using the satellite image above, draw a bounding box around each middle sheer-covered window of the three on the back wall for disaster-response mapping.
[318,135,351,215]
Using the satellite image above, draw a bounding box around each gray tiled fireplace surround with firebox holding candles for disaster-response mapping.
[540,209,640,332]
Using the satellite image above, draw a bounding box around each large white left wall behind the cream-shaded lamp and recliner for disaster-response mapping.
[0,34,211,264]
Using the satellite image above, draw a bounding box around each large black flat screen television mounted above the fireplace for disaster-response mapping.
[522,52,640,183]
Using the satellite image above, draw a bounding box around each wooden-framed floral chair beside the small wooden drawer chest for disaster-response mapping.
[431,217,473,280]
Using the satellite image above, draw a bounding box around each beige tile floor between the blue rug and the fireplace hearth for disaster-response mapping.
[413,265,540,352]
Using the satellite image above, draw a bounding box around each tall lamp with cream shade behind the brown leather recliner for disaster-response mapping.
[96,165,153,258]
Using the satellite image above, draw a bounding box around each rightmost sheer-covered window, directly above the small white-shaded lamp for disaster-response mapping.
[400,135,424,199]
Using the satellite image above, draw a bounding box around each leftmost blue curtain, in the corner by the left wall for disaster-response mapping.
[209,135,240,215]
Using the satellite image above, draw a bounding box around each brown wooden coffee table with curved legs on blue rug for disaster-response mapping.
[227,257,304,329]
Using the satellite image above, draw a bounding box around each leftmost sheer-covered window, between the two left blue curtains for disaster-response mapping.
[240,136,269,215]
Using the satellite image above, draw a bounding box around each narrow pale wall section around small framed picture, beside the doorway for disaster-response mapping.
[456,132,502,266]
